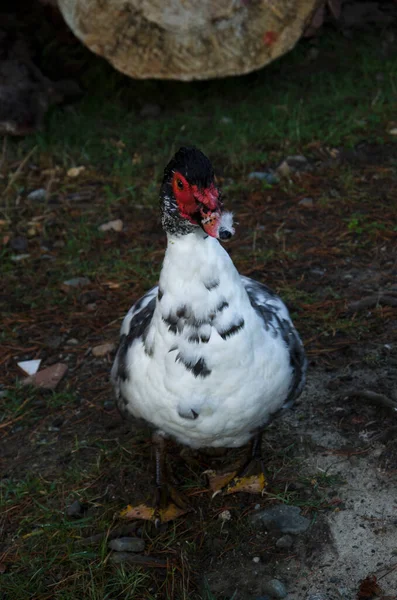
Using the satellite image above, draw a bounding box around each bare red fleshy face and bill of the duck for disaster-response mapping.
[172,172,221,238]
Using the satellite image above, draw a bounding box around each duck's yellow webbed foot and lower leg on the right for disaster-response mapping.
[205,433,267,497]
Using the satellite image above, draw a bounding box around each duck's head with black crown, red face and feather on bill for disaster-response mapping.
[160,147,234,240]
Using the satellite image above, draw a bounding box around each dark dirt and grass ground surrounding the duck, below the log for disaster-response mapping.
[0,9,397,600]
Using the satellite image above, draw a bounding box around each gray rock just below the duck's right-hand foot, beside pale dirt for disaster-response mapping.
[251,504,310,534]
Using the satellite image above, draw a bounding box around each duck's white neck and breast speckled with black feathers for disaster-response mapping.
[114,234,293,447]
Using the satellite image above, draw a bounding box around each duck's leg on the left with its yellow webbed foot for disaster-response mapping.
[121,432,190,525]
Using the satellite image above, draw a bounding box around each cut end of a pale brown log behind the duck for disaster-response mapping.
[58,0,324,81]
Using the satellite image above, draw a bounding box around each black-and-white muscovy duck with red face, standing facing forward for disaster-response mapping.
[112,147,306,520]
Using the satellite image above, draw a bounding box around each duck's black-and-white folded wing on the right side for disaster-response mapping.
[241,277,307,408]
